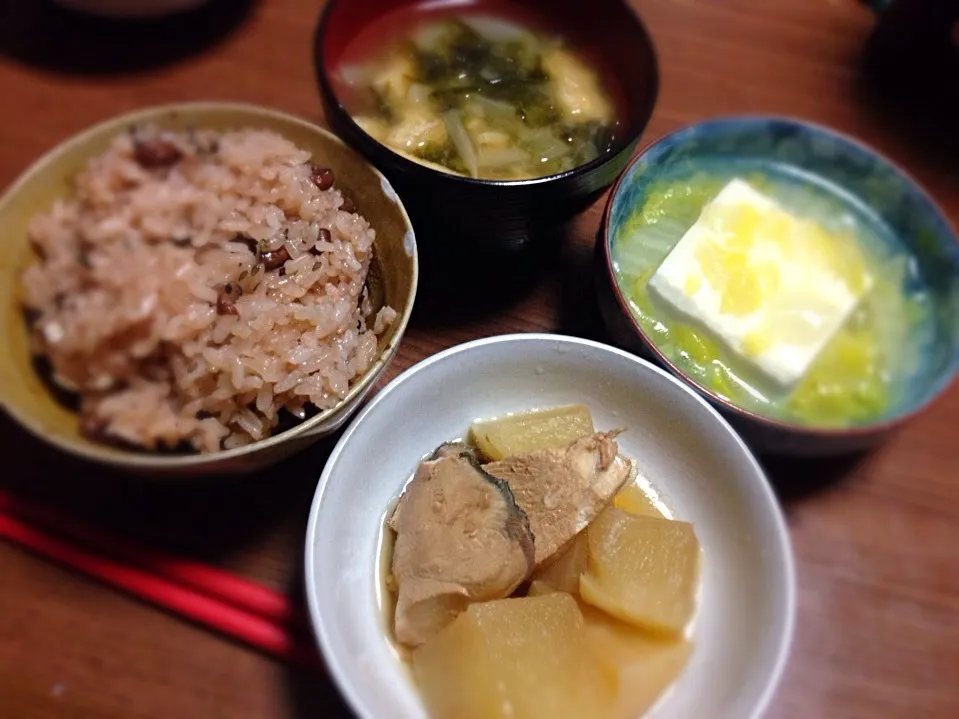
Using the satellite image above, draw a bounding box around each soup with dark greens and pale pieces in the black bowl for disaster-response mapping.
[334,6,621,180]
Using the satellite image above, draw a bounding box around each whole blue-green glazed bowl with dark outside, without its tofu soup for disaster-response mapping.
[596,117,959,456]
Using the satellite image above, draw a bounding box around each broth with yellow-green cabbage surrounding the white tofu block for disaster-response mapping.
[612,166,930,426]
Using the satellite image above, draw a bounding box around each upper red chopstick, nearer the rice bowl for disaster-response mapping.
[0,490,307,629]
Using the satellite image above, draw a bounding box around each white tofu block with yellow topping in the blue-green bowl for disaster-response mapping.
[649,179,873,388]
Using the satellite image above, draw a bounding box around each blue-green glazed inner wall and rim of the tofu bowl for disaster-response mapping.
[601,117,959,437]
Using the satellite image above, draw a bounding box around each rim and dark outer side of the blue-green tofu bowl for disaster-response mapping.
[594,115,956,458]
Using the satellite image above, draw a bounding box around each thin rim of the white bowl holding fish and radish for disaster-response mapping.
[303,332,797,719]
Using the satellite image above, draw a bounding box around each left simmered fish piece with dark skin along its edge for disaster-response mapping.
[390,444,534,646]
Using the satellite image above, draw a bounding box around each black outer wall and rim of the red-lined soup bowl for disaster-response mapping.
[313,0,659,260]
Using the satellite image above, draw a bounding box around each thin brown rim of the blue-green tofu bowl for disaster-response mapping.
[601,114,959,438]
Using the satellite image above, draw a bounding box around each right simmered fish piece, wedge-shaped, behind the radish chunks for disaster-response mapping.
[483,432,633,566]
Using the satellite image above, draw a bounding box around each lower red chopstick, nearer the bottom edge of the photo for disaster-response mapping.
[0,513,323,669]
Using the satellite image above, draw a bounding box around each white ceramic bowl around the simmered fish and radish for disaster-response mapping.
[306,334,795,719]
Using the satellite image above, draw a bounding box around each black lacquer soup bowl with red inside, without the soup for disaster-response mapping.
[314,0,658,271]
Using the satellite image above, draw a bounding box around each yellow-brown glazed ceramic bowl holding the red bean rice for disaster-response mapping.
[0,103,417,474]
